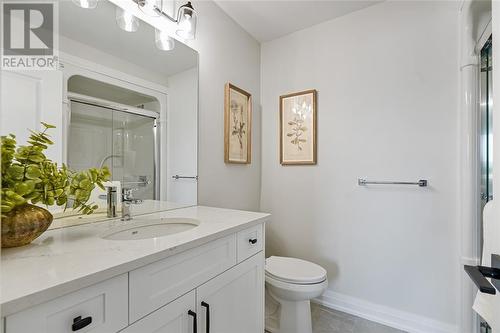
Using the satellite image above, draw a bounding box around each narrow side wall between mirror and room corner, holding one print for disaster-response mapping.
[190,1,261,210]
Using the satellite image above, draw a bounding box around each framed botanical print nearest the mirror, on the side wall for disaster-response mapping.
[224,83,252,164]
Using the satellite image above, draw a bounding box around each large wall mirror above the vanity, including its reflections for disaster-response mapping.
[1,1,198,227]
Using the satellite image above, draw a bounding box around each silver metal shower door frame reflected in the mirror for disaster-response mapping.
[67,92,161,200]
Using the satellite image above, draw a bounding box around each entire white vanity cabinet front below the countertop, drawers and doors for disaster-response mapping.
[4,224,264,333]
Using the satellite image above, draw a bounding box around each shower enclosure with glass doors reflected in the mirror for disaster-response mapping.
[68,75,161,200]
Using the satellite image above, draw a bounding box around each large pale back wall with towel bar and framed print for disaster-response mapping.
[261,1,461,332]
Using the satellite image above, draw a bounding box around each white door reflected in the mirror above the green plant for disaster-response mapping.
[0,70,63,163]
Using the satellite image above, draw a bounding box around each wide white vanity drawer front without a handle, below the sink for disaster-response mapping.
[129,235,236,323]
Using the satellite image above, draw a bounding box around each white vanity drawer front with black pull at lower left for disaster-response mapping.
[5,274,128,333]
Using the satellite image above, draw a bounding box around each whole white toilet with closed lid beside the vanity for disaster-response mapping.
[266,256,328,333]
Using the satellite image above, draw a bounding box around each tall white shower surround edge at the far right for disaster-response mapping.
[457,0,492,333]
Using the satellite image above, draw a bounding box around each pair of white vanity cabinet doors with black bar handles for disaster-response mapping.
[122,252,264,333]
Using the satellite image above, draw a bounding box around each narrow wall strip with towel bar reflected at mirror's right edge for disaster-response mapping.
[166,67,198,205]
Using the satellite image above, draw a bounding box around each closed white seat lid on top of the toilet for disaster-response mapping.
[266,256,326,284]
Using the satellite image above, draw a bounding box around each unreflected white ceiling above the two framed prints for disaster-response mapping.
[215,0,381,42]
